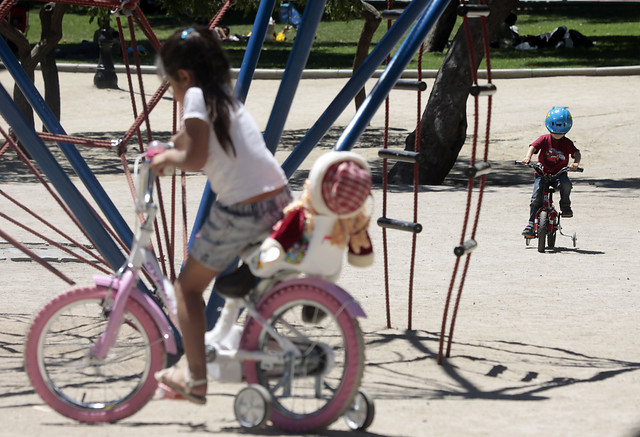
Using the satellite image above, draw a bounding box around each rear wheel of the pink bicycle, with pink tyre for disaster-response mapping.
[241,283,364,432]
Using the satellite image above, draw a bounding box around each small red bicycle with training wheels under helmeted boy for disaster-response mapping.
[515,161,584,253]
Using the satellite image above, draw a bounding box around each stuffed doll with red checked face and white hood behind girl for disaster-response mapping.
[243,151,373,281]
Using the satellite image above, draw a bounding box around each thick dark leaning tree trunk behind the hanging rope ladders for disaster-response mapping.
[389,0,517,185]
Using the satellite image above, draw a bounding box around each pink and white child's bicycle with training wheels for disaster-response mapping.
[25,146,374,432]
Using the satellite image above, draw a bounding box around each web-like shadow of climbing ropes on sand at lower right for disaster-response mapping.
[365,331,640,401]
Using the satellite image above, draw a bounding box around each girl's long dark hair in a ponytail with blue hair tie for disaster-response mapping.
[160,26,236,156]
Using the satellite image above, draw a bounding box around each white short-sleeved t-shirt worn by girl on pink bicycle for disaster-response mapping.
[182,87,287,205]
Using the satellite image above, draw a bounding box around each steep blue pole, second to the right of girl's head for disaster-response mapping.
[264,0,325,153]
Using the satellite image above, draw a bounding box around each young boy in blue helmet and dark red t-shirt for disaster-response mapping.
[522,106,581,237]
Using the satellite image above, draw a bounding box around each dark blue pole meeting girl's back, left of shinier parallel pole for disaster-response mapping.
[282,0,430,177]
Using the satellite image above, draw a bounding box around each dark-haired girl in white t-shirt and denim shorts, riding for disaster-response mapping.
[151,27,292,404]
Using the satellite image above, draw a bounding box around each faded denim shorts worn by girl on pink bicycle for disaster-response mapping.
[189,186,292,272]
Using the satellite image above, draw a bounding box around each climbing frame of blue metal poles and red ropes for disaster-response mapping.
[0,0,495,384]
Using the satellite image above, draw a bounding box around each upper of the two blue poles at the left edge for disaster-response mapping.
[0,38,133,249]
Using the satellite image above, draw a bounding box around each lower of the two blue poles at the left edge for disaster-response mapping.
[0,82,125,270]
